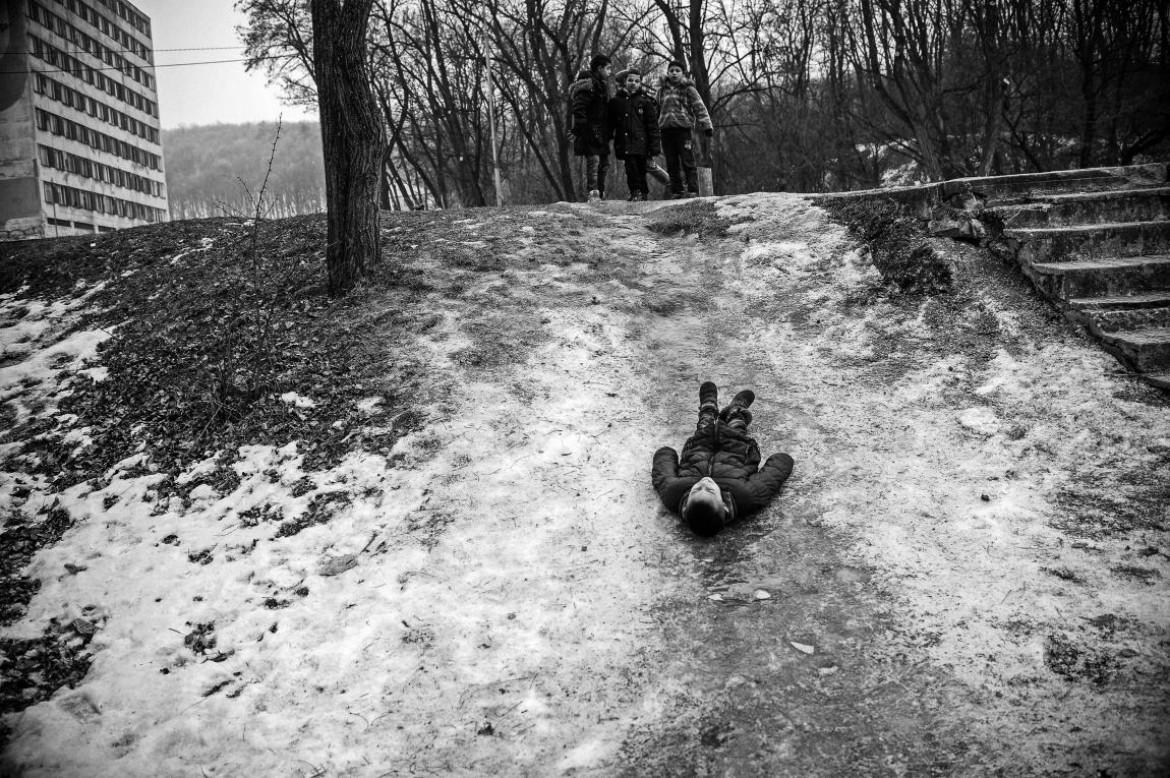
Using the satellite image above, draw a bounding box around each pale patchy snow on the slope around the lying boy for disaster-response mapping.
[0,195,1170,776]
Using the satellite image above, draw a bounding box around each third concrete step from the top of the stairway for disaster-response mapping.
[1004,220,1170,266]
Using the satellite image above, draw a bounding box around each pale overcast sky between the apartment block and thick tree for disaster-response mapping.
[131,0,317,129]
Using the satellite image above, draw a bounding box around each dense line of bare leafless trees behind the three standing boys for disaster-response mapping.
[236,0,1170,208]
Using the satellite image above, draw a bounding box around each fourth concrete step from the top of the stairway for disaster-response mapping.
[1024,254,1170,302]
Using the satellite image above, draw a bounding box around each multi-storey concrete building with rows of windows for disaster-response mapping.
[0,0,168,240]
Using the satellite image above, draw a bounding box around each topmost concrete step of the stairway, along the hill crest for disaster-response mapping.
[942,163,1168,201]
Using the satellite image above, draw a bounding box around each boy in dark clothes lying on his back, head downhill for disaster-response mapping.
[651,381,792,535]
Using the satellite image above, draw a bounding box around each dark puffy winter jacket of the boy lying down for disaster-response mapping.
[651,421,792,519]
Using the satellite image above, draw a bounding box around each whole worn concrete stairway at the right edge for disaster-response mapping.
[959,164,1170,388]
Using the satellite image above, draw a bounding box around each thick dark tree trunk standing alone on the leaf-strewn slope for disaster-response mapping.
[310,0,386,296]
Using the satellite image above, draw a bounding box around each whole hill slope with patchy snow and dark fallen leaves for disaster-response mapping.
[0,200,1170,777]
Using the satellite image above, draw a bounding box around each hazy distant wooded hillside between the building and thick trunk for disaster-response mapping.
[163,122,325,219]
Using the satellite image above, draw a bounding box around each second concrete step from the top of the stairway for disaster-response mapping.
[989,186,1170,229]
